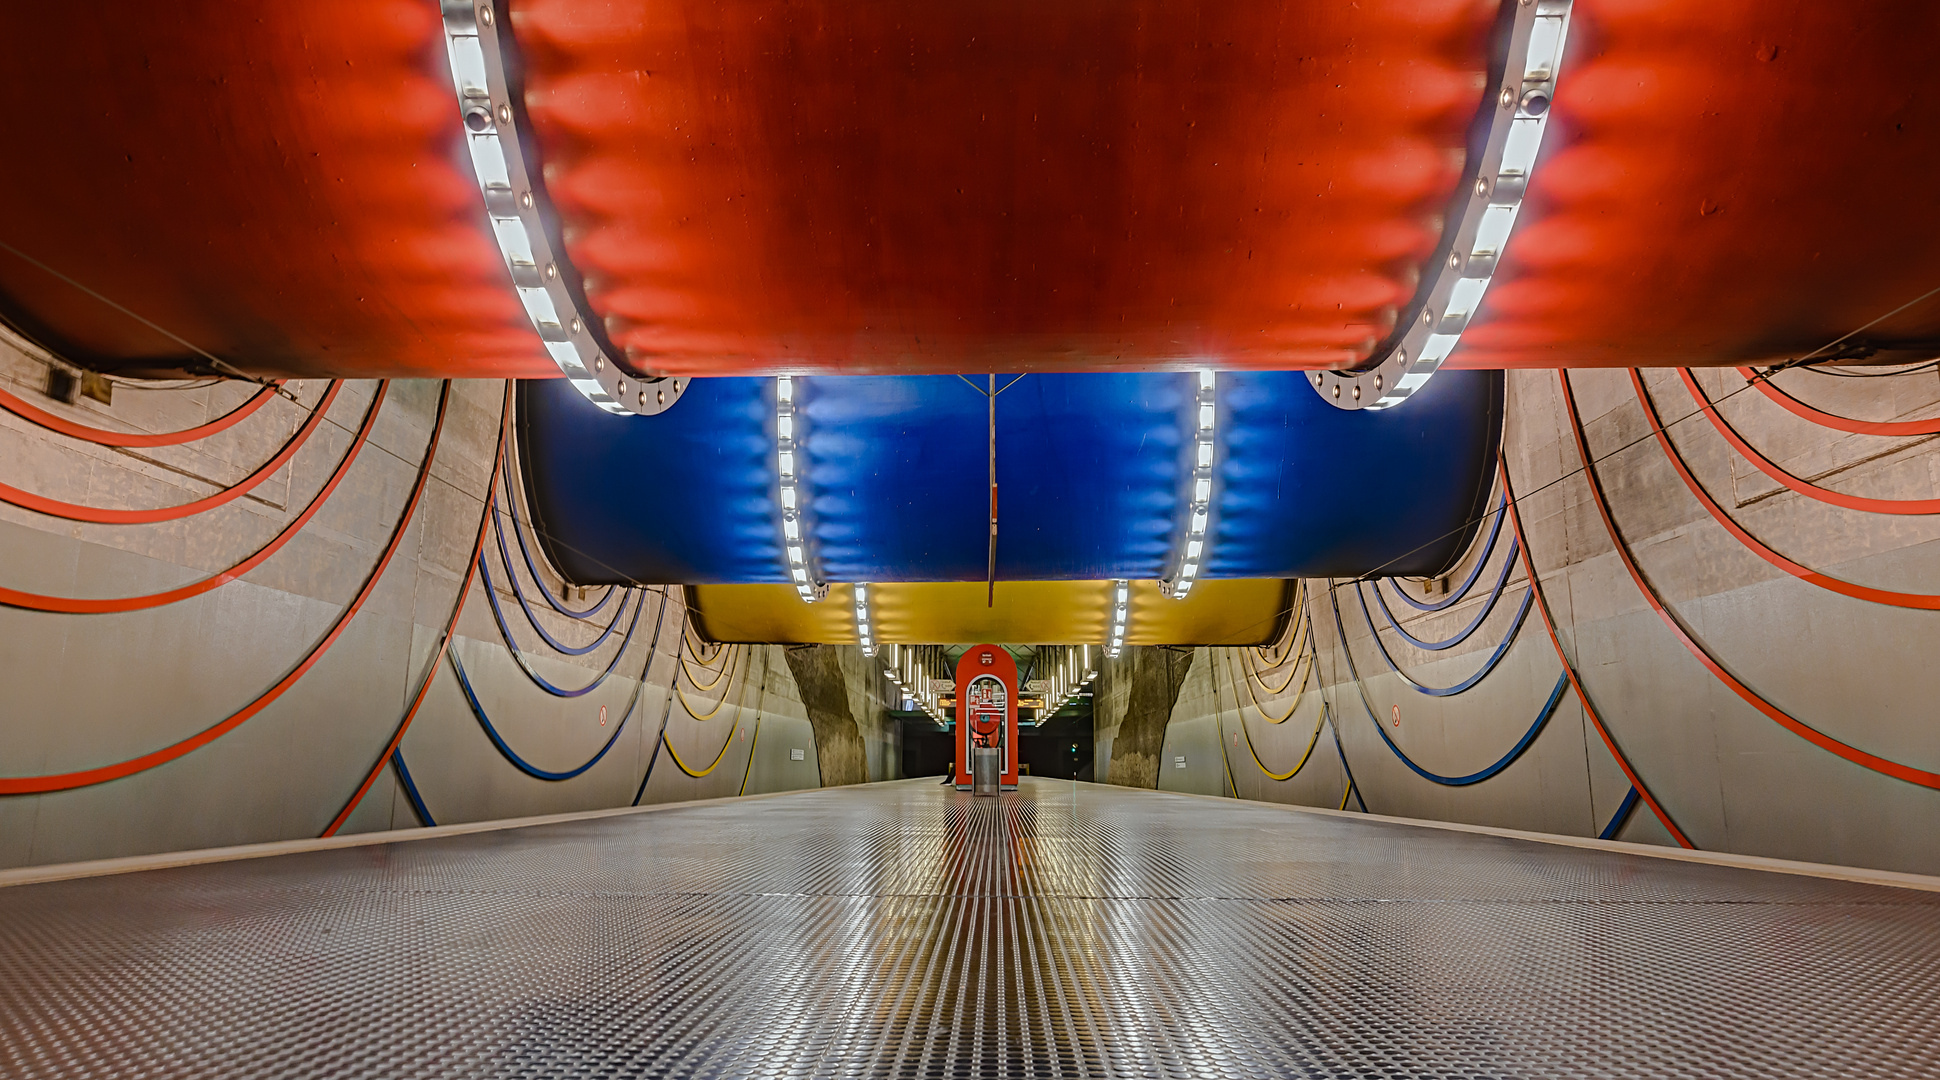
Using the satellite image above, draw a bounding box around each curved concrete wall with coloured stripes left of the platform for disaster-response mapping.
[0,337,819,867]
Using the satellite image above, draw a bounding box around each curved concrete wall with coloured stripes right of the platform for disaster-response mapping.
[1160,370,1940,873]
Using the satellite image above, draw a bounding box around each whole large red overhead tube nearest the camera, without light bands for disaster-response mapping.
[0,0,1940,376]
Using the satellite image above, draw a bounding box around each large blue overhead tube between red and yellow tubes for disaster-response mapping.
[520,372,1502,584]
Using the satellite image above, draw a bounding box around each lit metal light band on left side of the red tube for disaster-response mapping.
[440,0,691,415]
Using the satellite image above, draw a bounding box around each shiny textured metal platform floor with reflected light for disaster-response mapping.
[0,779,1940,1078]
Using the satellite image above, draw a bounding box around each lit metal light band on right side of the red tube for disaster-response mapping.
[1310,0,1571,409]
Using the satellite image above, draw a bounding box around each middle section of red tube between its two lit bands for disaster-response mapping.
[512,0,1498,376]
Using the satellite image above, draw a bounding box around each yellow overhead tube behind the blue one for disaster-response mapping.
[689,578,1290,646]
